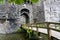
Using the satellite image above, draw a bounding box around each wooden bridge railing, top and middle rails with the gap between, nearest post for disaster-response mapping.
[22,22,60,40]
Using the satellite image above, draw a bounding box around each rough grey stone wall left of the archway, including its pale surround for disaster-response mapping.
[0,4,33,34]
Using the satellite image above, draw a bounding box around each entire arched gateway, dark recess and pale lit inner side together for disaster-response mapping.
[21,9,29,23]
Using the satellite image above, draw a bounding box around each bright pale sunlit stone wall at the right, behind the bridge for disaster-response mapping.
[44,0,60,22]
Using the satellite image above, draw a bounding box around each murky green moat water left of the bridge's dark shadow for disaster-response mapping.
[0,33,26,40]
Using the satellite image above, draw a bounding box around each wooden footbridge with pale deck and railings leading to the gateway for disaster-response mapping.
[22,22,60,40]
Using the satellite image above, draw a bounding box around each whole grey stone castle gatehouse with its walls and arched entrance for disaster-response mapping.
[0,0,60,34]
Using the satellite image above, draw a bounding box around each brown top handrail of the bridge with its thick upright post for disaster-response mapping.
[21,22,60,40]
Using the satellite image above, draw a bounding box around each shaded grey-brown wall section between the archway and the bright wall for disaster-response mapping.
[33,0,45,23]
